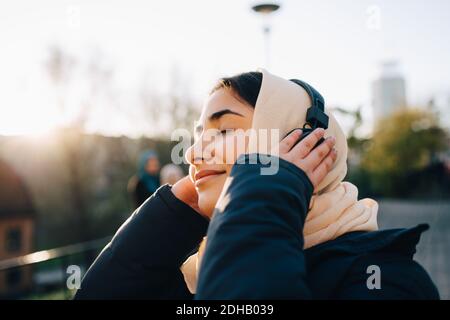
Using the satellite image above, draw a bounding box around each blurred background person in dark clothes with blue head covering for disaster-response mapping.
[128,150,161,208]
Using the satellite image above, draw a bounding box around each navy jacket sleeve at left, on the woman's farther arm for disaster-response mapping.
[75,185,208,299]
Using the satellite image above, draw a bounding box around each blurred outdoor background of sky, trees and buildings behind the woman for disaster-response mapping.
[0,0,450,299]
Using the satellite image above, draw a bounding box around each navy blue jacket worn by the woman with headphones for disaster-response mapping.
[75,155,439,299]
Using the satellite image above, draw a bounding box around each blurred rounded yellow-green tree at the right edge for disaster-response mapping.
[361,109,447,196]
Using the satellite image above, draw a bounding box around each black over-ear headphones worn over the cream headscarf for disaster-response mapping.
[285,79,328,149]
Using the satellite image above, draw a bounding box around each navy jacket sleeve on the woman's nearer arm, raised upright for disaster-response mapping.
[195,154,313,299]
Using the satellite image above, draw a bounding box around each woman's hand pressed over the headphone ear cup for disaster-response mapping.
[279,128,337,189]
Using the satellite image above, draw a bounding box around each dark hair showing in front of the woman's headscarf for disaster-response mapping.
[210,71,262,108]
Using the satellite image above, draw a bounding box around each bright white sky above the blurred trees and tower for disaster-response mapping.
[0,0,450,136]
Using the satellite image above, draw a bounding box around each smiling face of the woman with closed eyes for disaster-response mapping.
[186,88,253,217]
